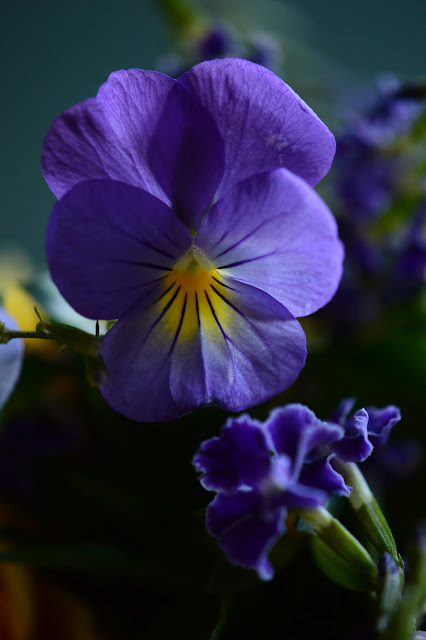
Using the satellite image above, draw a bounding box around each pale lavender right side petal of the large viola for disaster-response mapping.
[195,169,343,317]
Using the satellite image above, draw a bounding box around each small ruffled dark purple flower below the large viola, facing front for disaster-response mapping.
[193,404,344,580]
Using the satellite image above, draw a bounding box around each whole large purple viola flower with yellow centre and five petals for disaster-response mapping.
[42,59,343,420]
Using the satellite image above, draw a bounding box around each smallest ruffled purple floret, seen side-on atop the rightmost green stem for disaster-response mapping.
[329,398,401,462]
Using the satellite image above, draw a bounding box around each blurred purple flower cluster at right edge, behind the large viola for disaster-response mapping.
[326,78,426,335]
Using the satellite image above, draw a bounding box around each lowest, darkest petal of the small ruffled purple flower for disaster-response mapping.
[206,491,286,580]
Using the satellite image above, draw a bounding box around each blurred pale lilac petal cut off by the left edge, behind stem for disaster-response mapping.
[0,307,24,409]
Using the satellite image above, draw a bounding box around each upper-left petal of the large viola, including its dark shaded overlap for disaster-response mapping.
[42,69,224,226]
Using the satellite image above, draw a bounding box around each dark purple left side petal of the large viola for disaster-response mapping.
[46,180,191,319]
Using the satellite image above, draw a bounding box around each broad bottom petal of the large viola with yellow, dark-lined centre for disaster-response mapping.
[101,274,306,421]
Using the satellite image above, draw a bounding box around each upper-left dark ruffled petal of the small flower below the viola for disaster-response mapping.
[192,415,271,494]
